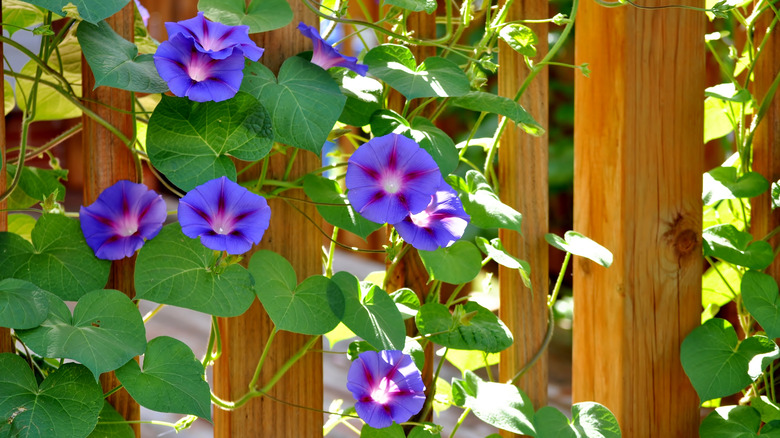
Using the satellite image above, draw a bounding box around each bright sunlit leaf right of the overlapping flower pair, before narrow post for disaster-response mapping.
[449,170,523,233]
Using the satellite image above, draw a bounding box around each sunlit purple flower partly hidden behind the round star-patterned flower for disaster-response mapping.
[393,181,471,251]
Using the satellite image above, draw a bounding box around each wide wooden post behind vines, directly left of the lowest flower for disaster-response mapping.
[214,2,323,438]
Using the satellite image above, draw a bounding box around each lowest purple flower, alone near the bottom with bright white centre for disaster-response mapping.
[347,350,425,429]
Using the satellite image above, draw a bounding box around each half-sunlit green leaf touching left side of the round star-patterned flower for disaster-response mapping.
[303,173,382,240]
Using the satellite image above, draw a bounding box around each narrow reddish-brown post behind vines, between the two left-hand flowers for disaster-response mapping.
[81,3,141,436]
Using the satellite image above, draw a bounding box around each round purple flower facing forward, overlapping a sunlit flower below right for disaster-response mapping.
[345,134,442,224]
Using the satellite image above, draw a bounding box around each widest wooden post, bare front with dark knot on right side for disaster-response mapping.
[573,1,705,437]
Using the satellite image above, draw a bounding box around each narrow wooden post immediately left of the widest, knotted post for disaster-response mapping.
[498,0,549,414]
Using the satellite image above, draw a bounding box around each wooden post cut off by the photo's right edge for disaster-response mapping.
[750,2,780,279]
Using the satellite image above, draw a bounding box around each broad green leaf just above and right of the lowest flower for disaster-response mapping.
[415,301,512,353]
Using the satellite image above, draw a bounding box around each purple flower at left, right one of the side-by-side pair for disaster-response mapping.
[179,176,271,254]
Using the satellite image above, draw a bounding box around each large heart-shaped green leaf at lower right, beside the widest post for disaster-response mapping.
[680,318,777,402]
